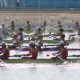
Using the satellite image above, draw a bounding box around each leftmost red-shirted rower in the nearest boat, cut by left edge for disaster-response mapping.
[0,44,10,59]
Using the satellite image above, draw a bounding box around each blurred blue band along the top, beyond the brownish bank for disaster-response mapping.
[0,0,80,10]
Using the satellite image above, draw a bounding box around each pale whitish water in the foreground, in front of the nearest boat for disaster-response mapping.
[0,64,80,80]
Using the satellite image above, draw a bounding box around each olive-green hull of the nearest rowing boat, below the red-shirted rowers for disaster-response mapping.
[3,59,78,64]
